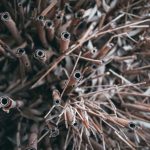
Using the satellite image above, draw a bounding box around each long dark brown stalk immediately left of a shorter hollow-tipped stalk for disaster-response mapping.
[36,16,49,48]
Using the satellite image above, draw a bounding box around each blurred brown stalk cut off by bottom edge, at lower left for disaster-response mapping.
[25,124,38,150]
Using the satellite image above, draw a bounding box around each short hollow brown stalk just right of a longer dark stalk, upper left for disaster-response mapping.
[45,20,55,42]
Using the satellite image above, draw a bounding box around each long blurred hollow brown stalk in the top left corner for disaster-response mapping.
[1,12,22,44]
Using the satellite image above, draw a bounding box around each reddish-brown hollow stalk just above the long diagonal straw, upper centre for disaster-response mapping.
[60,31,70,53]
